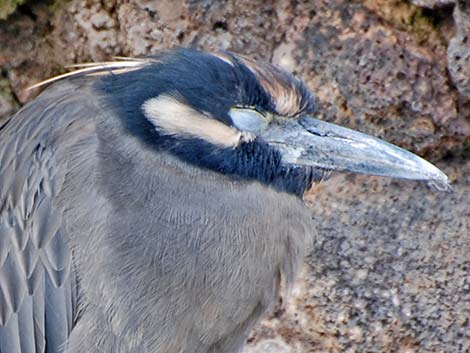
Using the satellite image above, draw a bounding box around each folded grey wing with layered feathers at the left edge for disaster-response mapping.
[0,82,96,353]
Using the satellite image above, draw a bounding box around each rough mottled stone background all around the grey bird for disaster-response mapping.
[0,0,470,353]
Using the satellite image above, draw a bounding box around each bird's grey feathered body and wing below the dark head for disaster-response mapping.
[0,60,314,353]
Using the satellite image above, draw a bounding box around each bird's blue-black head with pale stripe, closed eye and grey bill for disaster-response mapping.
[35,49,448,195]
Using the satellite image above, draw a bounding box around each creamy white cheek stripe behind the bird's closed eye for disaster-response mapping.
[142,94,247,148]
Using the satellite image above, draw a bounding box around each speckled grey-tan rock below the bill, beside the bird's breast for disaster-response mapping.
[246,155,470,353]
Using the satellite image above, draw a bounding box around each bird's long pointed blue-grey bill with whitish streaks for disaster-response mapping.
[261,116,450,190]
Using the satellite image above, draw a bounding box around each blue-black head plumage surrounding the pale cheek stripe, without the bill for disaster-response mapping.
[96,50,319,195]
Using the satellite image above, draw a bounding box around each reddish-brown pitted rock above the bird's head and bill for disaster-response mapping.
[0,0,470,159]
